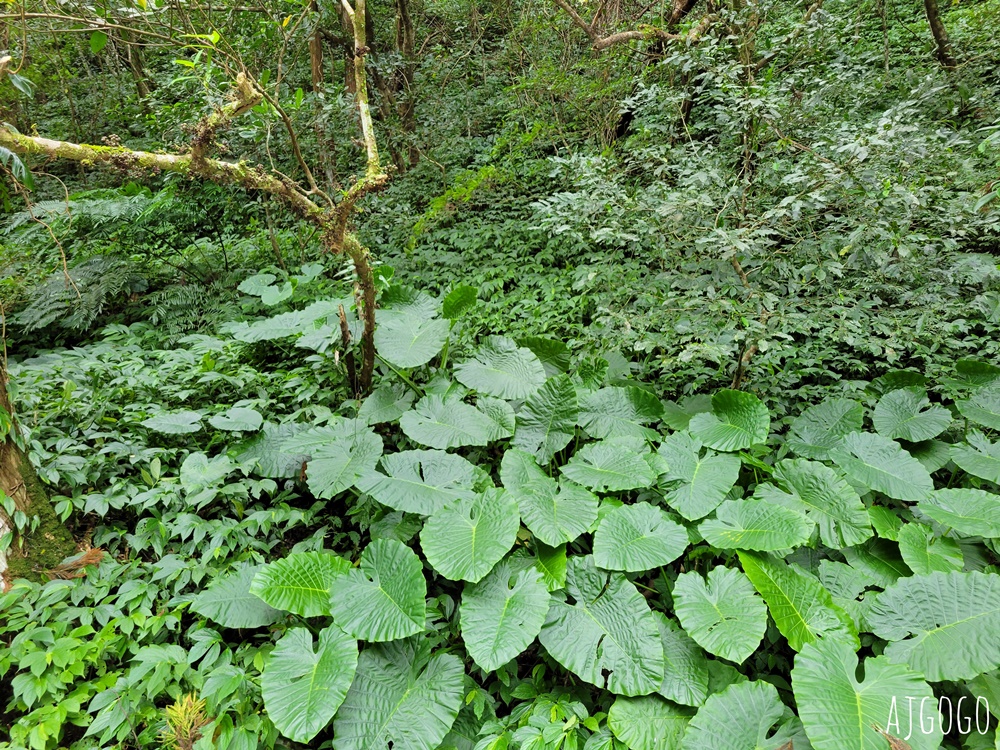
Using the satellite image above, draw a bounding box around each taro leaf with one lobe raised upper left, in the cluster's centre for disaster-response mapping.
[500,449,597,547]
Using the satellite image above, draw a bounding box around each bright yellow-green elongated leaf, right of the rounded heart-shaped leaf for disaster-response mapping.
[739,552,861,651]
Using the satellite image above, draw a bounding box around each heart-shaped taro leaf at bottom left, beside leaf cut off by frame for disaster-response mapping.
[260,625,358,742]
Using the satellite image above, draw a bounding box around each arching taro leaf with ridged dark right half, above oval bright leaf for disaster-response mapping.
[754,458,872,549]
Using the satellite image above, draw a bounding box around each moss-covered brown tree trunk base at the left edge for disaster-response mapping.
[0,363,76,590]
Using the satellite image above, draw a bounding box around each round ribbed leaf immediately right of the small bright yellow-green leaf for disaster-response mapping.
[330,539,427,641]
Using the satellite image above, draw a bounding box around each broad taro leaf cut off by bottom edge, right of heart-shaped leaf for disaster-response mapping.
[333,638,464,750]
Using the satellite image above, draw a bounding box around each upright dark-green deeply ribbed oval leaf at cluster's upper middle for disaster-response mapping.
[513,375,579,464]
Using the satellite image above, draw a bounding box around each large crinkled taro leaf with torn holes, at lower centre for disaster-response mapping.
[538,555,663,695]
